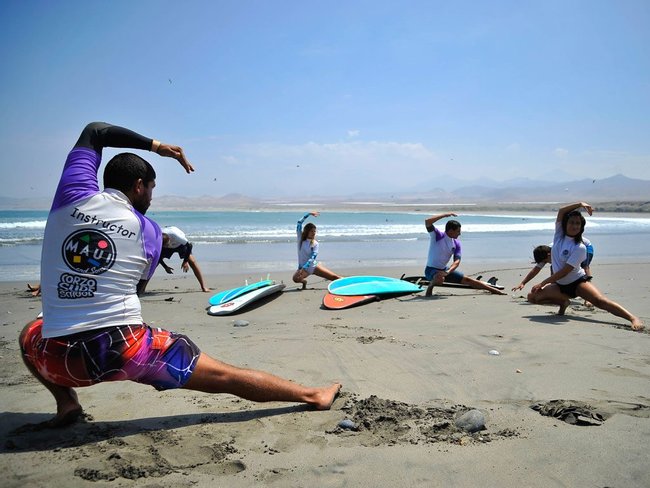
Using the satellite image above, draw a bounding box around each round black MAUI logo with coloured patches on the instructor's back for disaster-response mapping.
[62,230,115,275]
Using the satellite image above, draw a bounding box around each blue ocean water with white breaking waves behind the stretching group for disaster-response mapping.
[0,211,650,281]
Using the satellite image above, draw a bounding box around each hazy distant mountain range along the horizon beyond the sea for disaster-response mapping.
[0,174,650,211]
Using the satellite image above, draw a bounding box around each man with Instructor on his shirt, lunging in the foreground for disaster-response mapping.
[19,122,341,427]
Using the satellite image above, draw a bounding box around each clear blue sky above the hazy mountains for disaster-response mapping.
[0,0,650,197]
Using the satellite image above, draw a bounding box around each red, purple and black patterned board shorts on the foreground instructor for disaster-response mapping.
[20,319,201,390]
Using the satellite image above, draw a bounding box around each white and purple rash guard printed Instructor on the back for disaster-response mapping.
[41,124,162,338]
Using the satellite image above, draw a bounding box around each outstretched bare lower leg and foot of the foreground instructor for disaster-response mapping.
[184,353,341,410]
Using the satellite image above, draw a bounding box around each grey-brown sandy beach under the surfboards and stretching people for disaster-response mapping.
[0,262,650,488]
